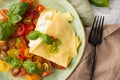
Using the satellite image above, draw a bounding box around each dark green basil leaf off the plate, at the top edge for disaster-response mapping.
[89,0,110,7]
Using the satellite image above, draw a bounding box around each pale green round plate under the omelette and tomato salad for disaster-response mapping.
[0,0,85,80]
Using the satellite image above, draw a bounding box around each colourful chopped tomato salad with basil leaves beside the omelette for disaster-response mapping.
[0,0,65,80]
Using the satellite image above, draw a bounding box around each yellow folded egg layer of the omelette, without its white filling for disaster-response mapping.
[30,8,80,68]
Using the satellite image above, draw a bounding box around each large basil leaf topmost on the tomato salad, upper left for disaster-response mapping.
[9,2,29,15]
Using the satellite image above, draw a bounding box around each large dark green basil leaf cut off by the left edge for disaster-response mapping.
[0,22,15,40]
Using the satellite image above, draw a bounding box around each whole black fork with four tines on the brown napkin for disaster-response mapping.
[88,16,104,80]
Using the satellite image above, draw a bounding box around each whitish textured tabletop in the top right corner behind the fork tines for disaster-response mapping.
[93,0,120,24]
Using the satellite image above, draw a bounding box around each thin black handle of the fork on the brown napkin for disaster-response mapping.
[90,46,96,80]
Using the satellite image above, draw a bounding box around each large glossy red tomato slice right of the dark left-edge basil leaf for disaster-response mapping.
[14,23,25,37]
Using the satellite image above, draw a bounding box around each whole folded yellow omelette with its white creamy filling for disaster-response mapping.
[29,9,80,68]
